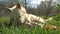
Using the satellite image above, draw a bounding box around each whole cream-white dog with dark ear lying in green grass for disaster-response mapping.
[6,3,52,27]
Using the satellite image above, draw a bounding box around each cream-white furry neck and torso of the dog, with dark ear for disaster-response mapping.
[17,4,45,23]
